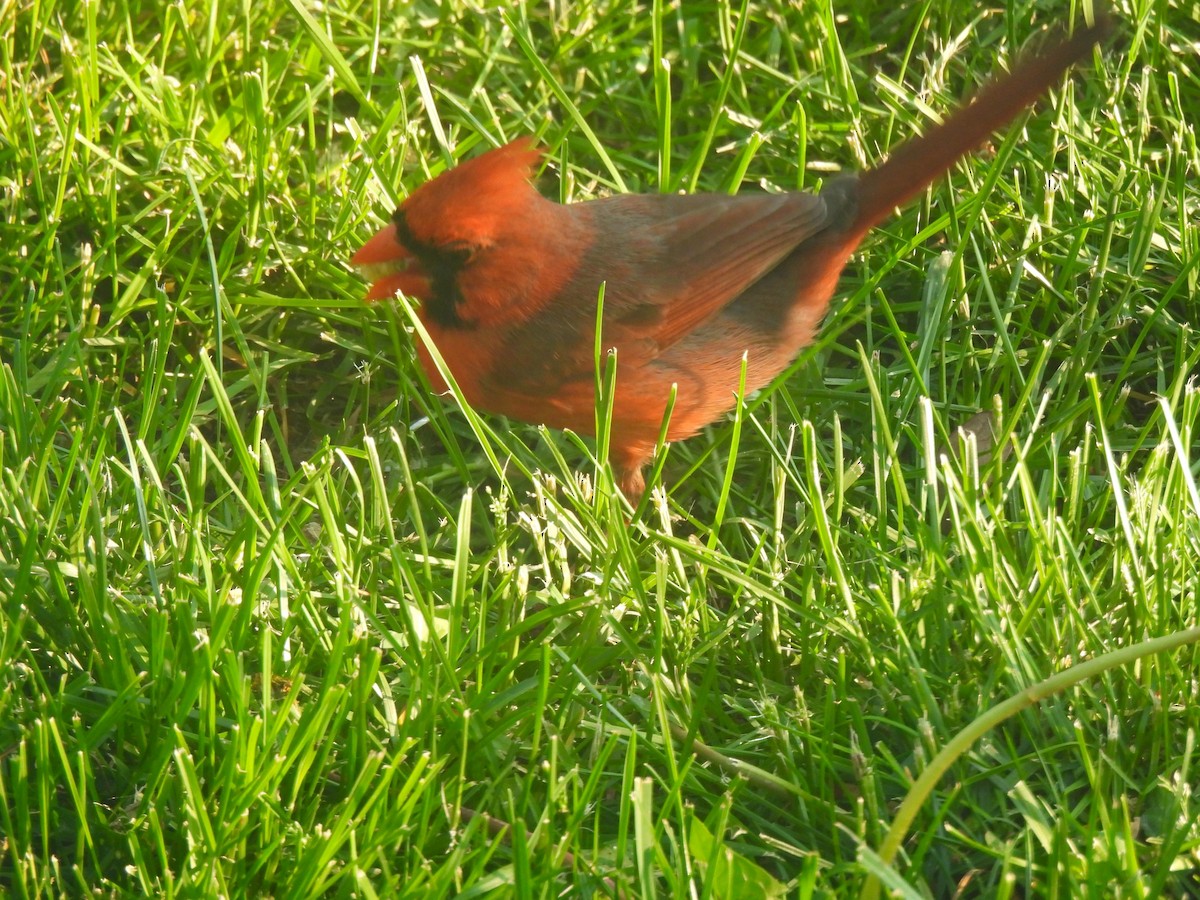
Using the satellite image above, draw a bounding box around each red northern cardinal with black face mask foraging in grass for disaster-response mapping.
[350,18,1109,503]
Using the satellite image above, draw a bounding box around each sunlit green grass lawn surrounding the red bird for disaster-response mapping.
[0,0,1200,898]
